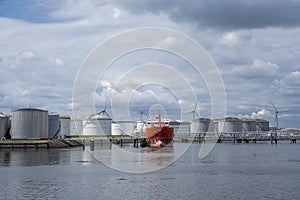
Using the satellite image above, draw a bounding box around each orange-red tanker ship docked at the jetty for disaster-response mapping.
[146,113,174,147]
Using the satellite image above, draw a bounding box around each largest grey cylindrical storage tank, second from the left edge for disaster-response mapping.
[11,108,48,139]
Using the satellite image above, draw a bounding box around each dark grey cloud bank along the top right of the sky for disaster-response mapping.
[115,0,300,29]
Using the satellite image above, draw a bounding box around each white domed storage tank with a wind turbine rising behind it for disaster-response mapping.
[82,114,112,135]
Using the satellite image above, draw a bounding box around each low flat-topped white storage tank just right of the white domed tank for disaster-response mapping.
[111,121,135,135]
